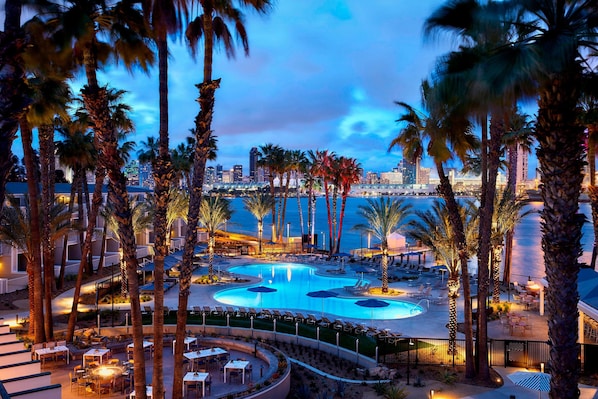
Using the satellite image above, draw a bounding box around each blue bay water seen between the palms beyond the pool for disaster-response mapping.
[227,197,594,282]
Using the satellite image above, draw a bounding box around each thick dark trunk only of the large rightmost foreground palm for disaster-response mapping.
[536,72,584,399]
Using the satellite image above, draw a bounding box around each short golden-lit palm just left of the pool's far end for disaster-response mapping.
[199,196,233,281]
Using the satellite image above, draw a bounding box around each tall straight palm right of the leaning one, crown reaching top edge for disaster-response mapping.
[425,0,529,380]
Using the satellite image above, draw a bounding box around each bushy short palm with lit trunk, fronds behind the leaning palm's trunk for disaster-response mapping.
[407,200,477,354]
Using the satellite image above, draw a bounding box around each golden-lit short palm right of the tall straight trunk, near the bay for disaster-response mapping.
[490,188,531,303]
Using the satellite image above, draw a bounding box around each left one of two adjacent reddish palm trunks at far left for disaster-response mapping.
[21,118,46,343]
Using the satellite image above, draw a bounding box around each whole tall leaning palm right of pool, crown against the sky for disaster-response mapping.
[389,81,477,378]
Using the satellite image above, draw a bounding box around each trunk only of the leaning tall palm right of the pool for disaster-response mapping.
[435,161,476,378]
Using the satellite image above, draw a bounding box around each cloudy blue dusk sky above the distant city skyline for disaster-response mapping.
[92,0,460,174]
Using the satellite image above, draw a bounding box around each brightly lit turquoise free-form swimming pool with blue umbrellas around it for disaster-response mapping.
[214,263,424,320]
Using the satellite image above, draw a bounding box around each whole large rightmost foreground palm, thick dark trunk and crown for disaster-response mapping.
[476,0,598,398]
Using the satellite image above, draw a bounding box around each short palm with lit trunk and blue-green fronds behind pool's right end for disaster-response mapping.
[355,197,411,293]
